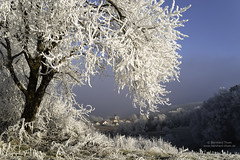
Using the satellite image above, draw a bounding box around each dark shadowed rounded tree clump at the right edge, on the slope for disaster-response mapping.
[190,85,240,145]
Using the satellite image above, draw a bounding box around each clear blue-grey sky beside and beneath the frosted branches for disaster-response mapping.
[75,0,240,116]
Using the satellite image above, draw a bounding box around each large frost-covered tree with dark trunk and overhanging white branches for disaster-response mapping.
[0,0,188,122]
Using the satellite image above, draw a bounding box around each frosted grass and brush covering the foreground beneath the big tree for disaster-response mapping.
[0,102,240,160]
